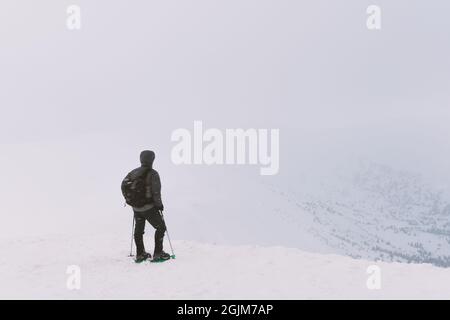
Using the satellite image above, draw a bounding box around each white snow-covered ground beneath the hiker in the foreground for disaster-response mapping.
[0,233,450,299]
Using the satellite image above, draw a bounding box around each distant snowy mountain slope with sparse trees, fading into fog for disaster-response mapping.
[273,163,450,267]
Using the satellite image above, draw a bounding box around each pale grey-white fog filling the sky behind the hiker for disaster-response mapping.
[0,0,450,242]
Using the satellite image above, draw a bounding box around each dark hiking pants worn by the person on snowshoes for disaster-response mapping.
[134,208,166,255]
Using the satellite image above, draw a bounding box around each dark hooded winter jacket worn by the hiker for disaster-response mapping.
[133,151,164,212]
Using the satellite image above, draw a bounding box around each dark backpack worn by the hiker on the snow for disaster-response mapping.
[121,168,150,208]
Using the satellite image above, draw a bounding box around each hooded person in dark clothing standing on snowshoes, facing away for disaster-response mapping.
[124,150,170,262]
